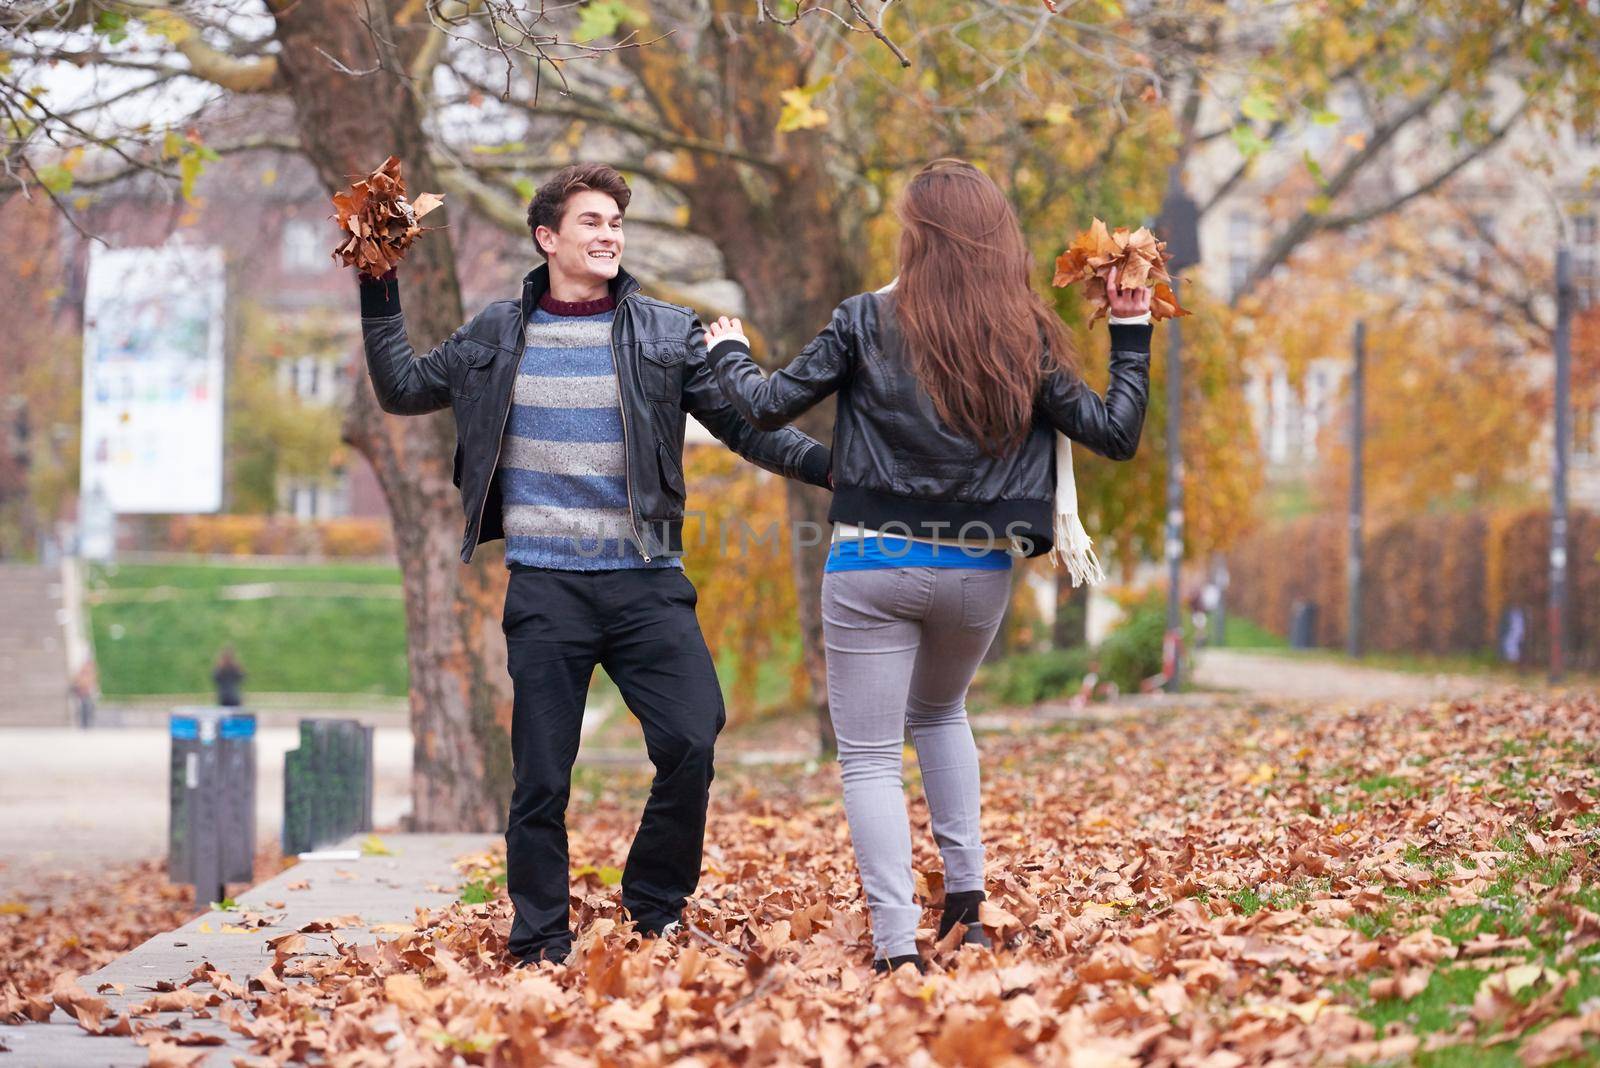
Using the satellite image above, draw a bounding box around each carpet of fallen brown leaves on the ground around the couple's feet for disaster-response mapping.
[12,694,1600,1068]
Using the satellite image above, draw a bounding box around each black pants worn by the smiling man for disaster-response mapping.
[502,568,725,959]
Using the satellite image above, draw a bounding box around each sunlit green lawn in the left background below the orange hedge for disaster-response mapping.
[88,563,408,700]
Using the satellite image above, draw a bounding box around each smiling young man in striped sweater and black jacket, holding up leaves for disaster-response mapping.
[362,165,829,962]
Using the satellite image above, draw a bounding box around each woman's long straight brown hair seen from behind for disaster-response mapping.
[891,160,1072,456]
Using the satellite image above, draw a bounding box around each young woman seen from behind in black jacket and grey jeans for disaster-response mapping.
[707,160,1150,970]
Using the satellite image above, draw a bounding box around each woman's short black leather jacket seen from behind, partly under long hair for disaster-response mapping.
[710,293,1150,556]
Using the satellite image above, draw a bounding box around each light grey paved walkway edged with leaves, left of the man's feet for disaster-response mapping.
[0,835,498,1068]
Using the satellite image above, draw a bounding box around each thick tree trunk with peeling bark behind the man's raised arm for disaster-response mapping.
[270,0,510,831]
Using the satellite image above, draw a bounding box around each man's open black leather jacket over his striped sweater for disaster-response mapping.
[362,265,829,561]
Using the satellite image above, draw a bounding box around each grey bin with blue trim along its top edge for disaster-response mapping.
[166,708,256,905]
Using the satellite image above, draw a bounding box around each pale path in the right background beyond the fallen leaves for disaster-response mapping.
[1194,649,1502,700]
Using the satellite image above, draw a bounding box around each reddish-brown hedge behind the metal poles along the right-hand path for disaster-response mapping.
[1227,512,1600,670]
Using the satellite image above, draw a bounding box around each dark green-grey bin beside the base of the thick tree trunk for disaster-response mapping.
[283,719,373,857]
